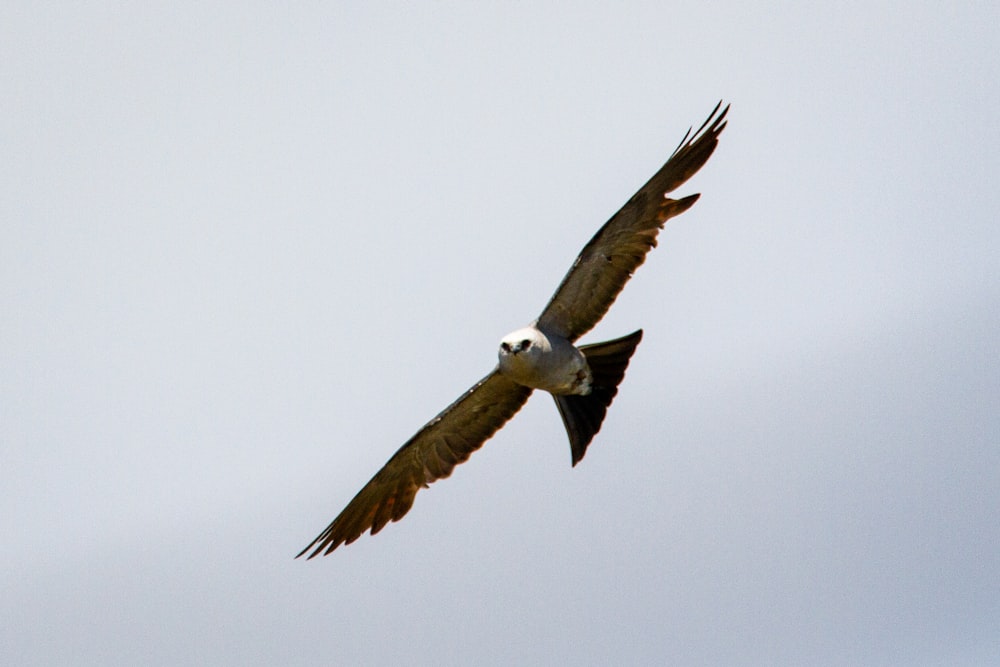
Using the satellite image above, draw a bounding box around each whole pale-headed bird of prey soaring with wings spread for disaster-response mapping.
[296,102,729,558]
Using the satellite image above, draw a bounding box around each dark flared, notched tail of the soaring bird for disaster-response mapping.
[552,329,642,465]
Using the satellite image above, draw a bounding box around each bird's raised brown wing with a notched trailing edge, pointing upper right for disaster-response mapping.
[537,102,729,341]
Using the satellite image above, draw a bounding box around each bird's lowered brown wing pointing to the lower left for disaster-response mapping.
[296,369,531,558]
